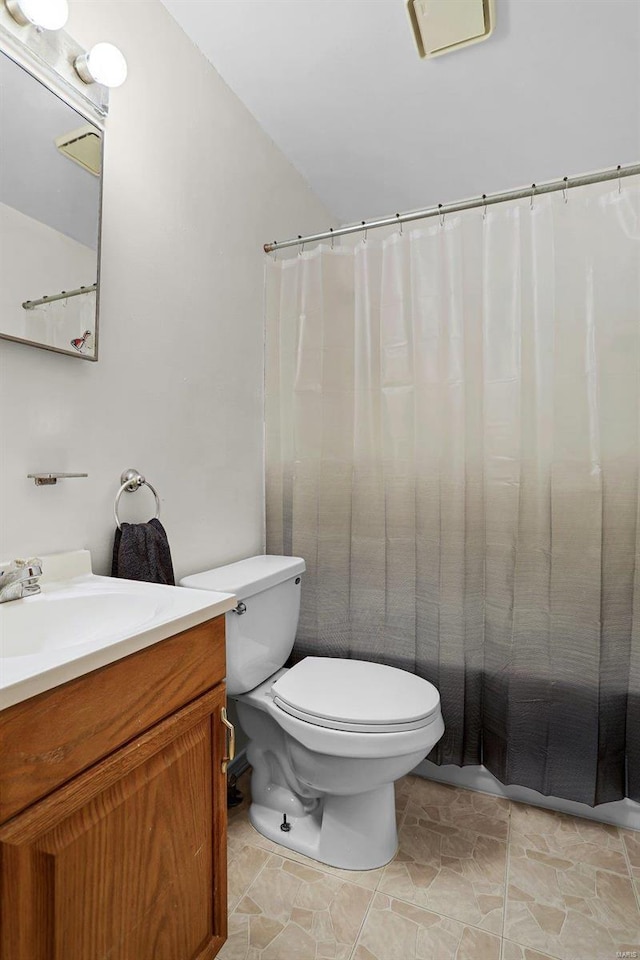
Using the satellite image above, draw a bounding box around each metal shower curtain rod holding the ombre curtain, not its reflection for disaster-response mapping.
[264,163,640,253]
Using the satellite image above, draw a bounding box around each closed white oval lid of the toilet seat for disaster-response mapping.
[272,657,440,733]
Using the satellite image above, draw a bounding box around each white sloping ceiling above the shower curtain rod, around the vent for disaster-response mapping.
[163,0,640,233]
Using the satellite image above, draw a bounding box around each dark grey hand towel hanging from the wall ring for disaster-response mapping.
[111,518,176,585]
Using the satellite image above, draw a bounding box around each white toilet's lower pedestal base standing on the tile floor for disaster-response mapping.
[249,783,398,870]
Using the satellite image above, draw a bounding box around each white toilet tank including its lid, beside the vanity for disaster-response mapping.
[180,556,305,694]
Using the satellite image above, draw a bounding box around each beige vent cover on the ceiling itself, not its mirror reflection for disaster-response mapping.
[408,0,495,57]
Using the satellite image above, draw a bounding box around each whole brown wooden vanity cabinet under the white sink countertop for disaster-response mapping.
[0,617,226,960]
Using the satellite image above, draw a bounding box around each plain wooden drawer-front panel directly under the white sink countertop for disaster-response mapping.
[0,617,225,823]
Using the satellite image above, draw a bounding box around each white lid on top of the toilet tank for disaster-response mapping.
[180,554,306,600]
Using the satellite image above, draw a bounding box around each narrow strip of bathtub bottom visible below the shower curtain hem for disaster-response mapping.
[411,760,640,830]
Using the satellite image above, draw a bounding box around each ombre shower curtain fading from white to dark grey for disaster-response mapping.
[266,178,640,805]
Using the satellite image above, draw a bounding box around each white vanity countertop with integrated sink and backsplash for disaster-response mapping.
[0,550,236,709]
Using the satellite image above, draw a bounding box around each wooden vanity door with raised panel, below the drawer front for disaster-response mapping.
[0,684,226,960]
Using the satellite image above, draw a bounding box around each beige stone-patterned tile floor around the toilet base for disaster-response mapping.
[218,774,640,960]
